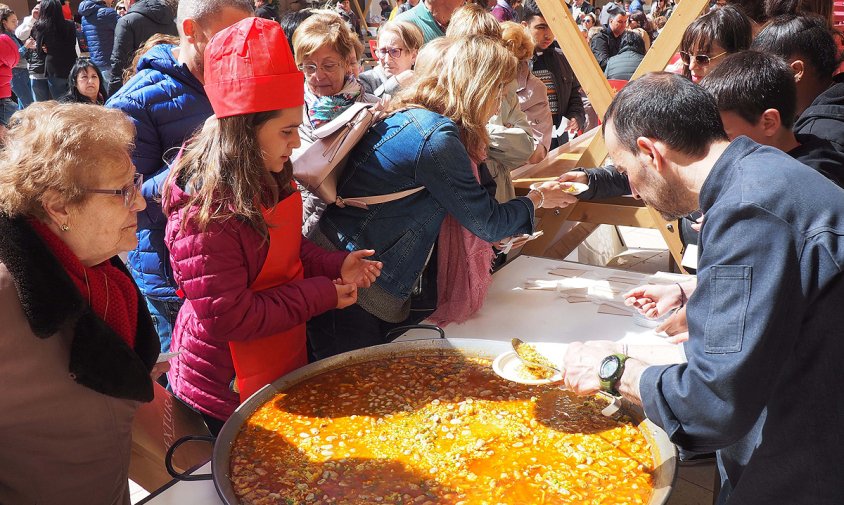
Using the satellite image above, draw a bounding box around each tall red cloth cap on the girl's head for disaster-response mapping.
[205,18,305,118]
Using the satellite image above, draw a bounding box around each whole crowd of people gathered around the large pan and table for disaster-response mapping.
[0,0,844,505]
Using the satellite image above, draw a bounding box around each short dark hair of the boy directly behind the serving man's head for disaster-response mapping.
[700,51,797,128]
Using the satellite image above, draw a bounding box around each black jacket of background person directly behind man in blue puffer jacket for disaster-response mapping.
[108,0,179,96]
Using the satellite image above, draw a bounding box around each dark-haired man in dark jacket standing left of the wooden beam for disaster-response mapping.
[522,0,585,149]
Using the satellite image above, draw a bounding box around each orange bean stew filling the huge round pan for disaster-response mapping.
[230,351,655,505]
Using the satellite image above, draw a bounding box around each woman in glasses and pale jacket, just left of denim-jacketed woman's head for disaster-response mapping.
[358,21,425,97]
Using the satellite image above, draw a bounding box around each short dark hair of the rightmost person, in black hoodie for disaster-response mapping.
[753,14,838,78]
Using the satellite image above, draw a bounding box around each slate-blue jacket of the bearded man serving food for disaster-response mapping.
[639,137,844,505]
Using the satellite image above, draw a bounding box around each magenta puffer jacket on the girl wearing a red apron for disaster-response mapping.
[164,183,347,420]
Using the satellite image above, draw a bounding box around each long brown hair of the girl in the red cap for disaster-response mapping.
[162,111,293,238]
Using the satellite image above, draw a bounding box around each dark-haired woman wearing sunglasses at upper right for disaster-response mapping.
[680,5,752,83]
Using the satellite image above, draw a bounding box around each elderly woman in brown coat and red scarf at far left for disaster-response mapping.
[0,102,159,505]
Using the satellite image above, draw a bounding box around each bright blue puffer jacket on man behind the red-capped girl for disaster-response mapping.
[106,45,213,301]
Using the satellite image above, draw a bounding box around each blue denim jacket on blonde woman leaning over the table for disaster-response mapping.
[320,109,534,300]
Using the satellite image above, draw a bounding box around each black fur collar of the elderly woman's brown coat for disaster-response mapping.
[0,215,160,402]
